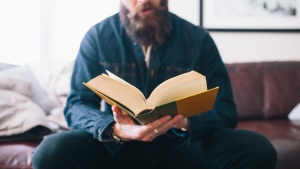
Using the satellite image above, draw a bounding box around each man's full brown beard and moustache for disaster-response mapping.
[120,0,171,47]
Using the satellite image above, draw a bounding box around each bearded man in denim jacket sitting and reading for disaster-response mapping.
[33,0,276,169]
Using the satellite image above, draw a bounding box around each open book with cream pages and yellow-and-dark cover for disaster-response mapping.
[83,71,219,125]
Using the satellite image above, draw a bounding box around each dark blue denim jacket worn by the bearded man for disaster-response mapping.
[65,13,237,154]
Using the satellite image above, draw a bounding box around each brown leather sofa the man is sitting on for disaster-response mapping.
[0,61,300,169]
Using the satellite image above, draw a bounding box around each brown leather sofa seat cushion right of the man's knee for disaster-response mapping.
[237,119,300,169]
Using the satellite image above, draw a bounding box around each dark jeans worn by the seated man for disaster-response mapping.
[33,129,276,169]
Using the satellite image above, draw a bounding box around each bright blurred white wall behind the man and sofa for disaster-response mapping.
[0,0,300,65]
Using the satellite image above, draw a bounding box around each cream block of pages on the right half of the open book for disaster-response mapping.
[147,71,207,109]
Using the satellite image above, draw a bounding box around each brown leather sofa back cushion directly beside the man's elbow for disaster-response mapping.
[226,63,263,119]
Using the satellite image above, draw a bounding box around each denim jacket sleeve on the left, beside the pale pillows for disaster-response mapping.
[64,27,122,154]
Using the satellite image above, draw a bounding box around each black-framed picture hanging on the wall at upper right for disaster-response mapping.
[200,0,300,32]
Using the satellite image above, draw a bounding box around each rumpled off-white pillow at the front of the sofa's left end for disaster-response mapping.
[0,89,50,136]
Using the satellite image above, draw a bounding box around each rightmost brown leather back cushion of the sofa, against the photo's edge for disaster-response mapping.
[262,61,300,118]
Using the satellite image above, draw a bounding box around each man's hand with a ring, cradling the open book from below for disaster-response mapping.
[112,106,188,142]
